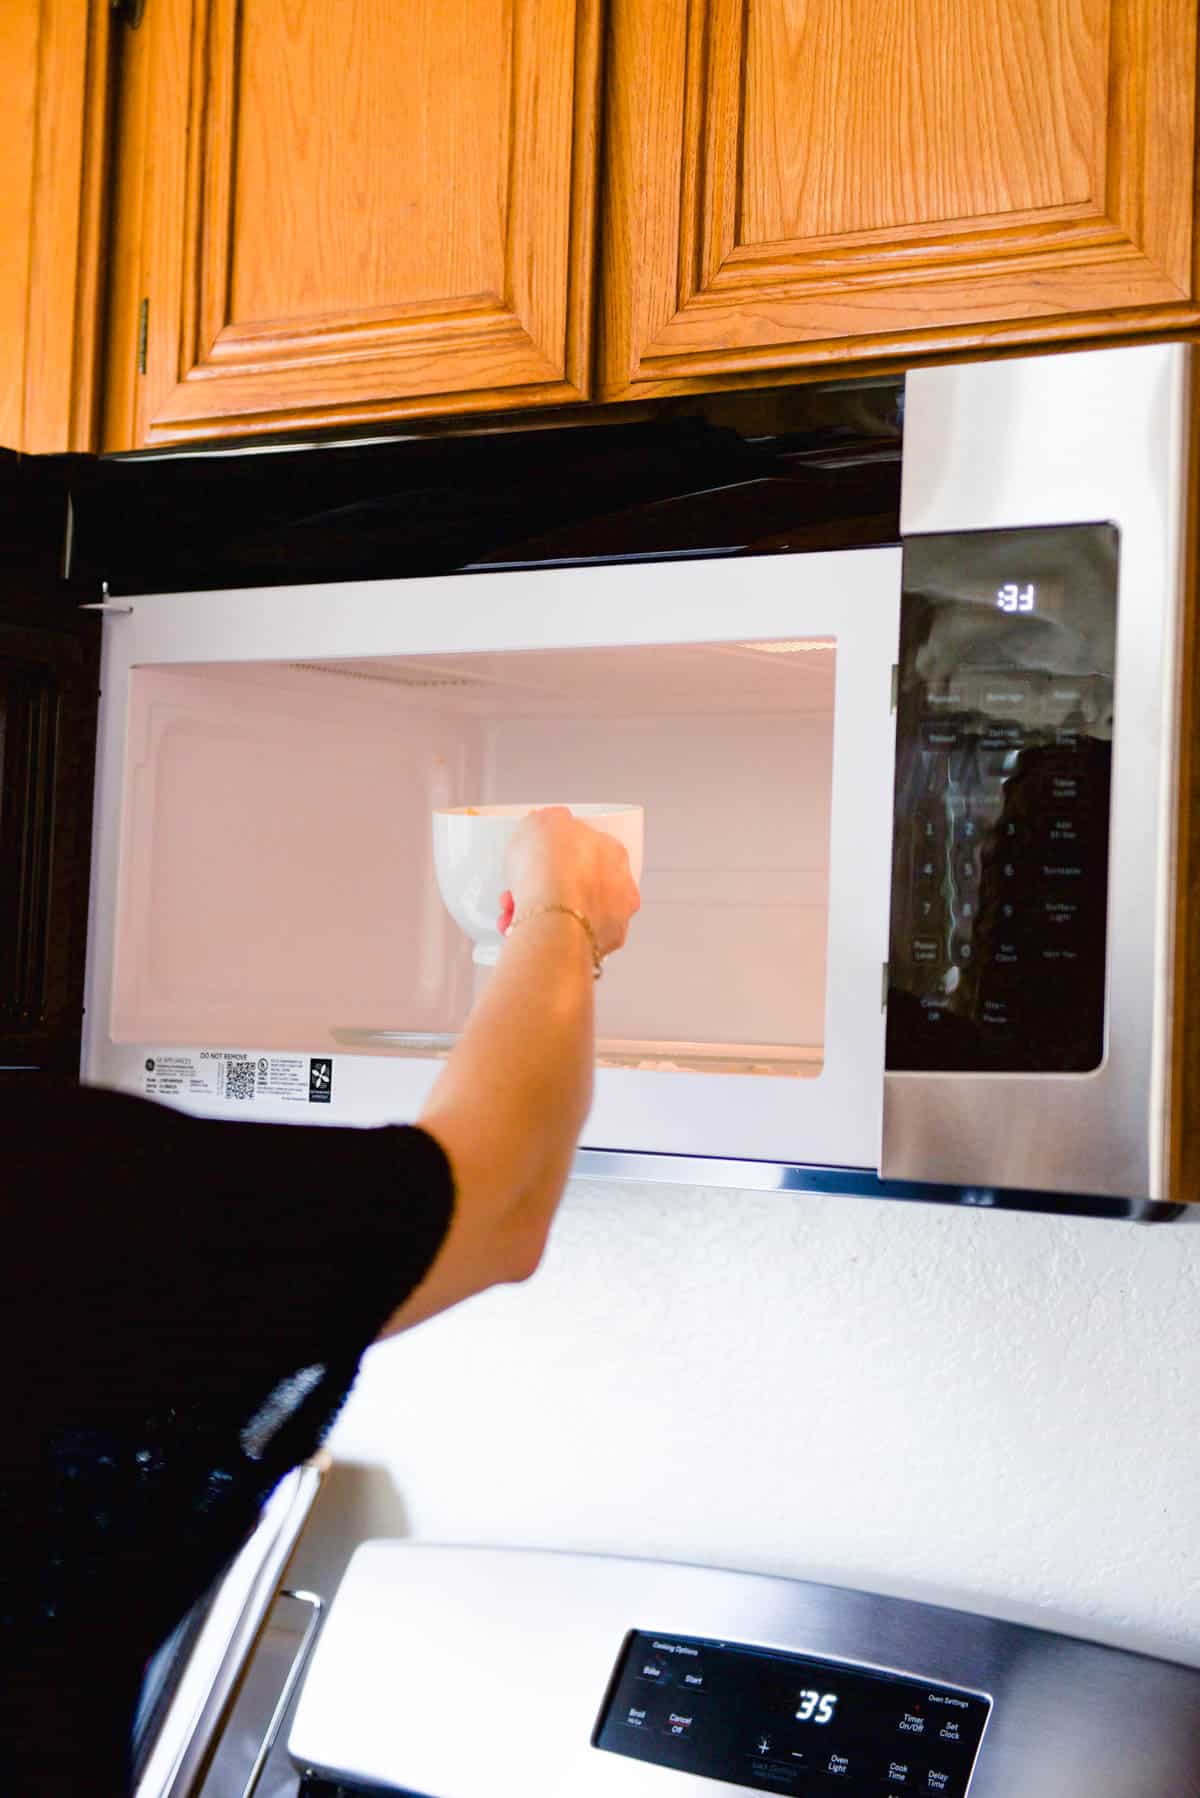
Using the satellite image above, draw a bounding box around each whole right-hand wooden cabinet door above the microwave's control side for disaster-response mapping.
[603,0,1200,397]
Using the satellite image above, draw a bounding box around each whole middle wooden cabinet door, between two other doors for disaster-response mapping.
[104,0,597,450]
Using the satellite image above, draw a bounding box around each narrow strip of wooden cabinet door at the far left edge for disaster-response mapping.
[0,0,110,455]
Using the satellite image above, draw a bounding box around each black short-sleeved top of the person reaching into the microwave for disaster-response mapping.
[0,1075,453,1798]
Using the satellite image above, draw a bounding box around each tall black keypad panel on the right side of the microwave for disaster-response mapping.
[887,525,1117,1073]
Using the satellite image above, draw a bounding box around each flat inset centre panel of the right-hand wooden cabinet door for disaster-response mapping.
[738,0,1108,243]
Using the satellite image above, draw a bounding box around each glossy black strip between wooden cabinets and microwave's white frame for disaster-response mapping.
[70,379,903,604]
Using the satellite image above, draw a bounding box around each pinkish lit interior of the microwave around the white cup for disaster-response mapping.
[110,636,837,1079]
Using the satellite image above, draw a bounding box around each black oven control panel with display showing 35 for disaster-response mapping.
[592,1631,991,1798]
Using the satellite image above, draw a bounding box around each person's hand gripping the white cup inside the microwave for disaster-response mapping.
[500,806,642,955]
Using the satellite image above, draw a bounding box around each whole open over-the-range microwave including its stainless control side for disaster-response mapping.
[83,343,1200,1217]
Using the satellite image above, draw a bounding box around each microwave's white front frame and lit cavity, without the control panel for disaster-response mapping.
[85,548,901,1169]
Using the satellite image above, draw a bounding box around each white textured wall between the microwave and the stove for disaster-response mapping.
[297,1183,1200,1663]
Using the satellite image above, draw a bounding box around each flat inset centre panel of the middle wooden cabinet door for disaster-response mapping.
[228,0,513,325]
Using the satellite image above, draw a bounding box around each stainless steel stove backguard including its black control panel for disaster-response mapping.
[275,1541,1200,1798]
